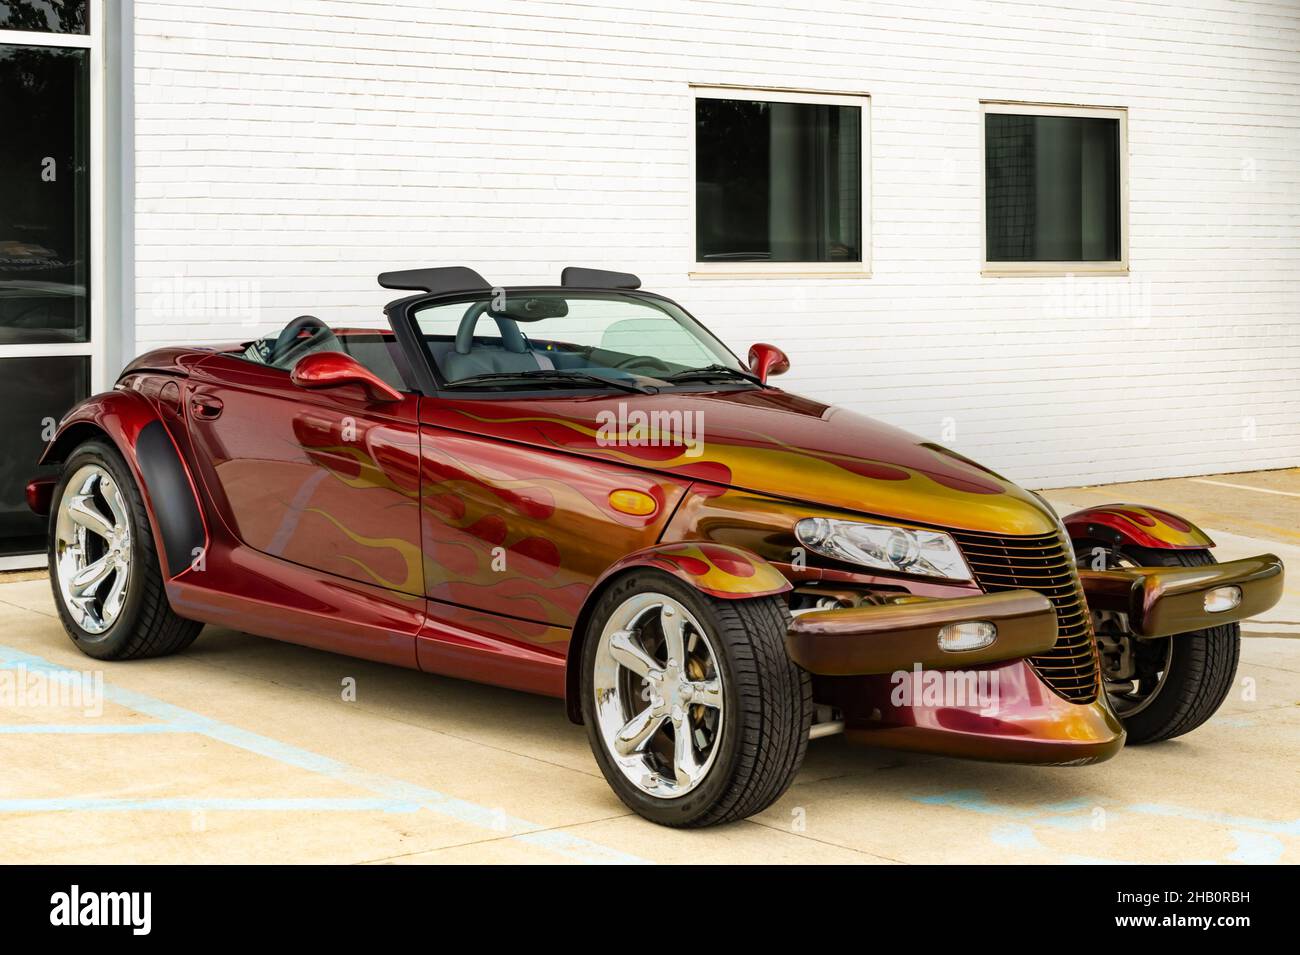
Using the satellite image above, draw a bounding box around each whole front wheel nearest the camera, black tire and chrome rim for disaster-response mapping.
[582,569,813,828]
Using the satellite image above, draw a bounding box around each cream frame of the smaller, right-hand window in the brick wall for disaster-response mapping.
[979,100,1128,278]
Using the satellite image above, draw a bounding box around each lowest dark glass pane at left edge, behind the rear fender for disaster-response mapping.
[0,355,90,556]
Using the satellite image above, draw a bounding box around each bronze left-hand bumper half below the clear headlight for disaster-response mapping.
[785,590,1057,677]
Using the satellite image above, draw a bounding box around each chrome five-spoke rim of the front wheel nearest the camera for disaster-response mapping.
[592,592,725,799]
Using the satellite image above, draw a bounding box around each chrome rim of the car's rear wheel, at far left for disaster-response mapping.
[52,464,133,634]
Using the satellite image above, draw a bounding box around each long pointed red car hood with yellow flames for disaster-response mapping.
[425,388,1058,534]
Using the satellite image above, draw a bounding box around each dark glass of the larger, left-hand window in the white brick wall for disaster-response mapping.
[696,97,862,262]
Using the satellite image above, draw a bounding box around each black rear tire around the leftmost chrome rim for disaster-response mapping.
[49,439,203,660]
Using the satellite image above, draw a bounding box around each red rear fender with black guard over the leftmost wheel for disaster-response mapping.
[29,391,208,578]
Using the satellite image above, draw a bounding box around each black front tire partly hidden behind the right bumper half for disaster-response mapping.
[1099,546,1242,745]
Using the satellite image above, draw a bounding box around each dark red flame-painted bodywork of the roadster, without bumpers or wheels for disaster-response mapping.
[38,335,1216,763]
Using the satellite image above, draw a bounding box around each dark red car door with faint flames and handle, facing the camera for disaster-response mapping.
[190,356,424,599]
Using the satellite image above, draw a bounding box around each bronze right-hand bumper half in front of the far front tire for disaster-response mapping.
[1079,554,1284,638]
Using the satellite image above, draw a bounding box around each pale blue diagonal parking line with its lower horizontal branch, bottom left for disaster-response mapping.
[0,646,649,864]
